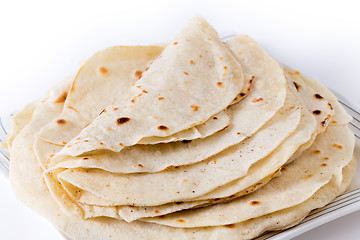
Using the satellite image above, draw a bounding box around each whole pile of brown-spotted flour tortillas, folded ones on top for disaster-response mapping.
[7,17,356,239]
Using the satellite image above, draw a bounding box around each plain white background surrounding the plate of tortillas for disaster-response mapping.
[0,0,360,240]
